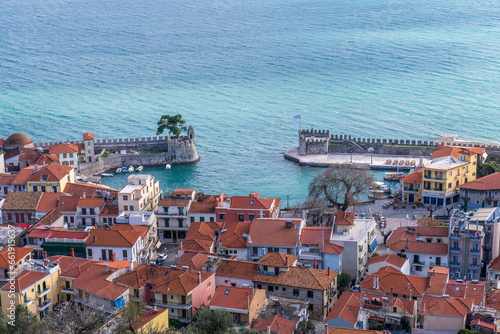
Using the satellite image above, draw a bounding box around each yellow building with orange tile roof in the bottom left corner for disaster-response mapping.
[0,262,60,320]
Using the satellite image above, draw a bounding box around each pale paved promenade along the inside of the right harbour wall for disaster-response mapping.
[284,148,430,170]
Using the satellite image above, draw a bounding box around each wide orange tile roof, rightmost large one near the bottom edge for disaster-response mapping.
[419,295,473,318]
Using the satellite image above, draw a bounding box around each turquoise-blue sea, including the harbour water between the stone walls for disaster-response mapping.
[0,0,500,205]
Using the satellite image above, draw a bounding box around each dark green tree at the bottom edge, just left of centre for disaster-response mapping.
[188,306,237,334]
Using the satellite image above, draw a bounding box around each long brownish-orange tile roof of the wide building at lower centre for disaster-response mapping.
[253,267,338,290]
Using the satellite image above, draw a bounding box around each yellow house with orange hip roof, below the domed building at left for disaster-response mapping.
[26,163,75,193]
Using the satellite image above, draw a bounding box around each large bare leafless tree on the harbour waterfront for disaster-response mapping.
[308,165,373,211]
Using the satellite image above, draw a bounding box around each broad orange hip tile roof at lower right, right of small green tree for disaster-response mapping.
[361,267,429,296]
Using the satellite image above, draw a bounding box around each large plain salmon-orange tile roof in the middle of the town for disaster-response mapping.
[247,218,302,247]
